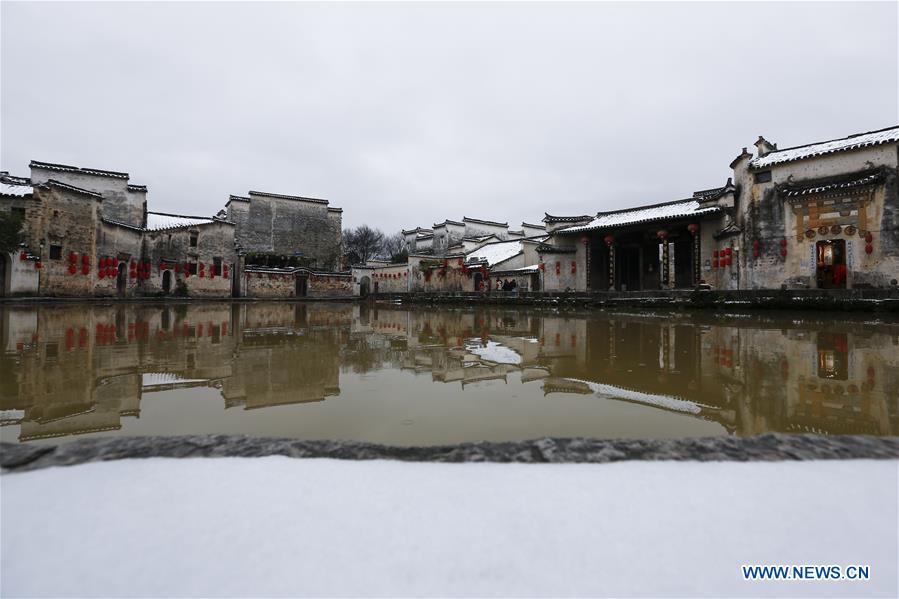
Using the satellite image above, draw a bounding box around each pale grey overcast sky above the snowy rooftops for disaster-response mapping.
[0,2,899,231]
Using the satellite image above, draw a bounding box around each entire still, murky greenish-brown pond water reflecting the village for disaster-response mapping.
[0,302,899,445]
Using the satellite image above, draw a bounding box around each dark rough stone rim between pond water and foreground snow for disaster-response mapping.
[0,433,899,473]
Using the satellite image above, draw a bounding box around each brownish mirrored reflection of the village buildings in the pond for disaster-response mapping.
[0,303,899,440]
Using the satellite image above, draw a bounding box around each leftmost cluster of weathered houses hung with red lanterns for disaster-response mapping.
[0,161,237,297]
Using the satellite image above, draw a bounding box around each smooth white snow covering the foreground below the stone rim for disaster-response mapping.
[0,457,899,597]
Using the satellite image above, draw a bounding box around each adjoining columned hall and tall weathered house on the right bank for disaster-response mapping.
[538,127,899,291]
